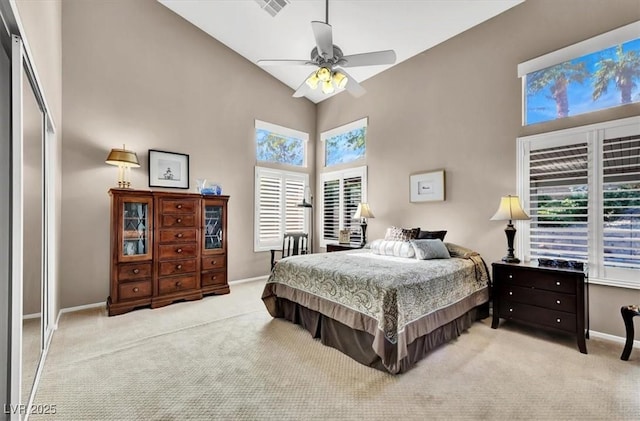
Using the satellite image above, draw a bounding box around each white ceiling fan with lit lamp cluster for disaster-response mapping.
[258,0,396,97]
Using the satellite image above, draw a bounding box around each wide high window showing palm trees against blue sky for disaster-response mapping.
[518,22,640,124]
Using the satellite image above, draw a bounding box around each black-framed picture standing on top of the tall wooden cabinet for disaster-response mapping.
[149,149,189,189]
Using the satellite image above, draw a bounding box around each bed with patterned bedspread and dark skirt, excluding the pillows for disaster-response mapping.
[262,243,490,374]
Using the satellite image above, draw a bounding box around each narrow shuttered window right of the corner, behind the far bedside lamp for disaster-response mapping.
[320,167,367,247]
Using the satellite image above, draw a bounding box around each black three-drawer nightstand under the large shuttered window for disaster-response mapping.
[491,262,589,354]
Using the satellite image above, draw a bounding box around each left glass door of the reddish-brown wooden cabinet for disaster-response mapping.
[121,200,151,258]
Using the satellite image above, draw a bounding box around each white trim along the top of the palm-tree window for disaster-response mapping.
[518,21,640,77]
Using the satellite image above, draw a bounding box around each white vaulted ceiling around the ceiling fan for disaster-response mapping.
[158,0,524,103]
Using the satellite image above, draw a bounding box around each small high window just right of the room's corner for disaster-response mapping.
[320,118,367,167]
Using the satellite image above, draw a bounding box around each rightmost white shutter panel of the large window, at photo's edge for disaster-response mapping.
[602,136,640,269]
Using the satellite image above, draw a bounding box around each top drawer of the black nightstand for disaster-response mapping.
[494,267,579,294]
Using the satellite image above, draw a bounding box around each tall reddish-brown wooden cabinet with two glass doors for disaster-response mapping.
[107,189,229,316]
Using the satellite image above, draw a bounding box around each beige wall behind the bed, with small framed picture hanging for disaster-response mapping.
[316,0,640,336]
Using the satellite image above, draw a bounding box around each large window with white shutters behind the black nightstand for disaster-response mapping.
[518,117,640,288]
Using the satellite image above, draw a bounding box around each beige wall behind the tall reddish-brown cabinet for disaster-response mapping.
[62,0,315,307]
